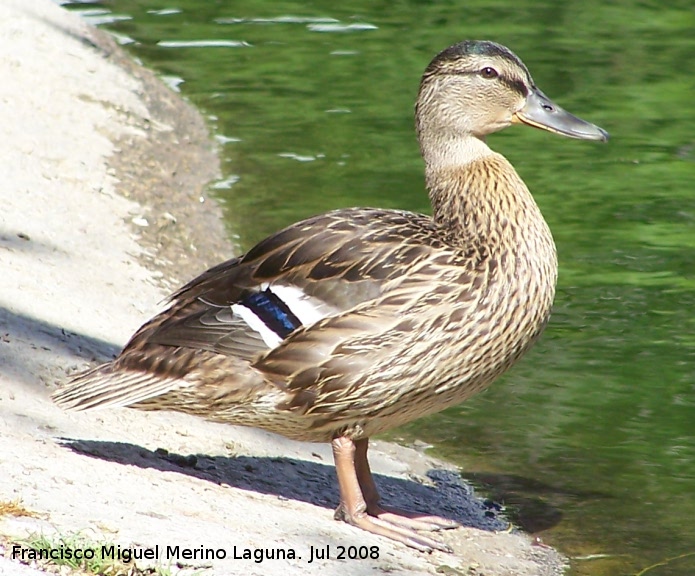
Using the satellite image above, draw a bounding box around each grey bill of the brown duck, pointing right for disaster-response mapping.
[512,88,608,142]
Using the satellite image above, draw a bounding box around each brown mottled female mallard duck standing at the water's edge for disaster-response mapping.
[54,41,608,551]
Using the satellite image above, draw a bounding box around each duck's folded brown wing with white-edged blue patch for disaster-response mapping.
[143,209,444,361]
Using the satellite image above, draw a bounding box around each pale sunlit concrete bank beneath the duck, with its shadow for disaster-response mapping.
[0,0,562,576]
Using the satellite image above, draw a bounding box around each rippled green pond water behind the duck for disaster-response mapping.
[65,0,695,576]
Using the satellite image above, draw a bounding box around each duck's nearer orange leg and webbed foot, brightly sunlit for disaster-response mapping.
[331,436,452,552]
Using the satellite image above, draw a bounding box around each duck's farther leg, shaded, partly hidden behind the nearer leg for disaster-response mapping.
[354,438,461,530]
